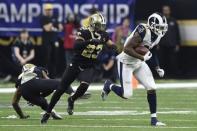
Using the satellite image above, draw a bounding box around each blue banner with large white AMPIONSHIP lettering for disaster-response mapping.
[0,0,135,36]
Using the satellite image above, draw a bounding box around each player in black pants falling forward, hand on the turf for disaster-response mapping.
[12,64,88,119]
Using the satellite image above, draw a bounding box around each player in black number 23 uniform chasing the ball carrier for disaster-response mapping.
[41,13,113,123]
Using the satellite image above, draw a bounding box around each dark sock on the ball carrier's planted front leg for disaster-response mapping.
[147,90,157,114]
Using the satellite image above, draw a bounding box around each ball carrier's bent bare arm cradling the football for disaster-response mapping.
[124,32,144,61]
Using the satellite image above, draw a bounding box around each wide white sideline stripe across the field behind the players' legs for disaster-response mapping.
[0,83,197,93]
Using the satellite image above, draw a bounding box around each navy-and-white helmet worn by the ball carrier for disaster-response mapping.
[147,13,168,37]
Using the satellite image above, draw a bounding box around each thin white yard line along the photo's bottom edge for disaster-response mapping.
[0,125,197,129]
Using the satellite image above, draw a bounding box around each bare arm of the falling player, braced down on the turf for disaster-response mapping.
[12,88,25,118]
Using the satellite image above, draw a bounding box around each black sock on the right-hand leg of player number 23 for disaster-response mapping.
[71,83,89,101]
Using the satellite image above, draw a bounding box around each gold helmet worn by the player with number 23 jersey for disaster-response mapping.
[89,13,106,31]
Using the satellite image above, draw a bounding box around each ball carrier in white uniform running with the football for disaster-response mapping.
[101,13,168,126]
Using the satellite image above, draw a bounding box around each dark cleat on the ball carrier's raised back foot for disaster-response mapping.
[101,80,112,101]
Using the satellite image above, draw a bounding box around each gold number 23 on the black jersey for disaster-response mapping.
[81,44,103,59]
